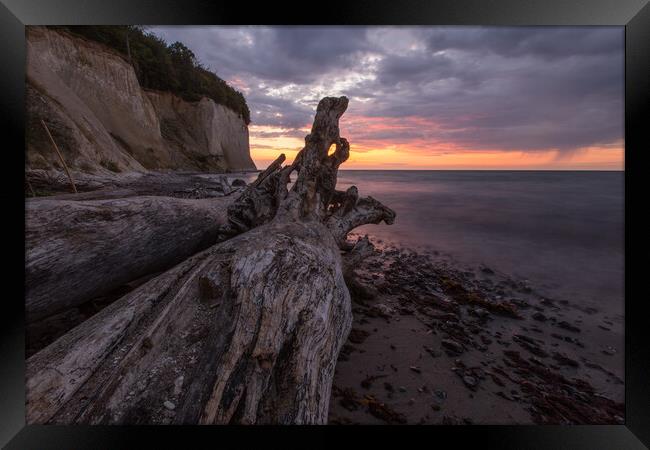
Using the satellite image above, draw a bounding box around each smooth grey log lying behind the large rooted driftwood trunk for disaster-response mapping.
[25,196,234,324]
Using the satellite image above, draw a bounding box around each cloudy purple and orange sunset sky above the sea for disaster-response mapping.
[149,26,624,170]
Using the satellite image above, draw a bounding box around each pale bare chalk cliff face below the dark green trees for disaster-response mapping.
[27,27,255,172]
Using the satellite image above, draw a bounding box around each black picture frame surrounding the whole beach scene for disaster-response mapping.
[0,0,650,450]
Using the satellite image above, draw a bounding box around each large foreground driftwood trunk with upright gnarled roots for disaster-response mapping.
[27,97,395,424]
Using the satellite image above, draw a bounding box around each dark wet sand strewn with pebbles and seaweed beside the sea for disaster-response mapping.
[329,239,624,424]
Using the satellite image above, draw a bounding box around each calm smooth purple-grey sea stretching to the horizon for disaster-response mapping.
[338,171,624,314]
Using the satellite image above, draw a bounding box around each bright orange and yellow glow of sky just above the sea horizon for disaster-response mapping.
[250,118,624,170]
